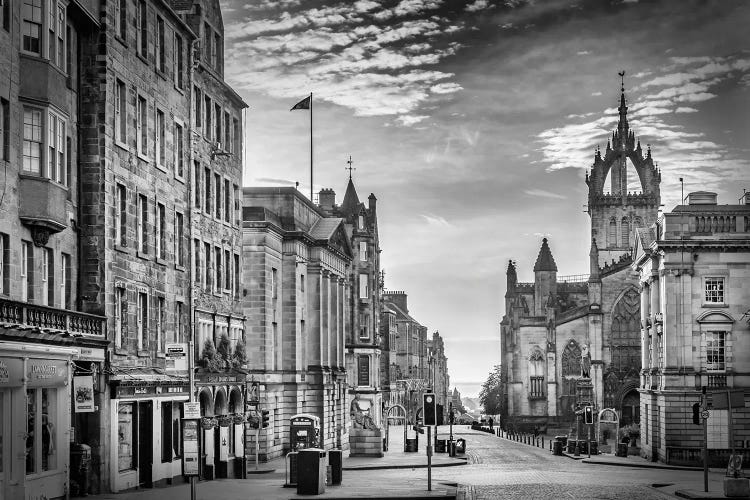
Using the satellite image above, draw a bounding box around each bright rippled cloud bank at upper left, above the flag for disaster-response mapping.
[226,0,465,126]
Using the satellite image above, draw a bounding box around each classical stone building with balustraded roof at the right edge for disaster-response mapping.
[632,192,750,466]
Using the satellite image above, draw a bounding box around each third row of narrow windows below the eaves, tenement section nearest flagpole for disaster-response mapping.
[193,238,241,297]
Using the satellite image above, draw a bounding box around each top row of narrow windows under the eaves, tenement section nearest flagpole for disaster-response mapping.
[193,85,242,156]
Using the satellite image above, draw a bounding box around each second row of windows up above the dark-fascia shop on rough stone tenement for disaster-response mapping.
[115,183,185,267]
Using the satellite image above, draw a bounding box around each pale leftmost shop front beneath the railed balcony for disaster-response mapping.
[0,342,78,500]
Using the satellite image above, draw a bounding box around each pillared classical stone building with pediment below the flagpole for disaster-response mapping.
[241,188,353,460]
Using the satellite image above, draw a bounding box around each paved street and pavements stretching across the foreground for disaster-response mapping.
[79,426,748,500]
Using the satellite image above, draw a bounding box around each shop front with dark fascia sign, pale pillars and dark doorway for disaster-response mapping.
[109,373,190,491]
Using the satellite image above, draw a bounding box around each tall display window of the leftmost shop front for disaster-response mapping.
[26,388,58,475]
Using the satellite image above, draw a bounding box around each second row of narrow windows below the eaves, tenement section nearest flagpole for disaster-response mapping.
[193,160,240,224]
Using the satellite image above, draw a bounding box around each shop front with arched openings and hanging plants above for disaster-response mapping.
[196,372,246,480]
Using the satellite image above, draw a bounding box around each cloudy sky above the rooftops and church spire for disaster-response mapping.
[221,0,750,396]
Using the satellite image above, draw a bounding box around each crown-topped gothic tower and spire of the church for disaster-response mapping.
[586,71,661,273]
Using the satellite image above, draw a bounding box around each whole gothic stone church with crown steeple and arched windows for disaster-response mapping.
[501,72,661,438]
